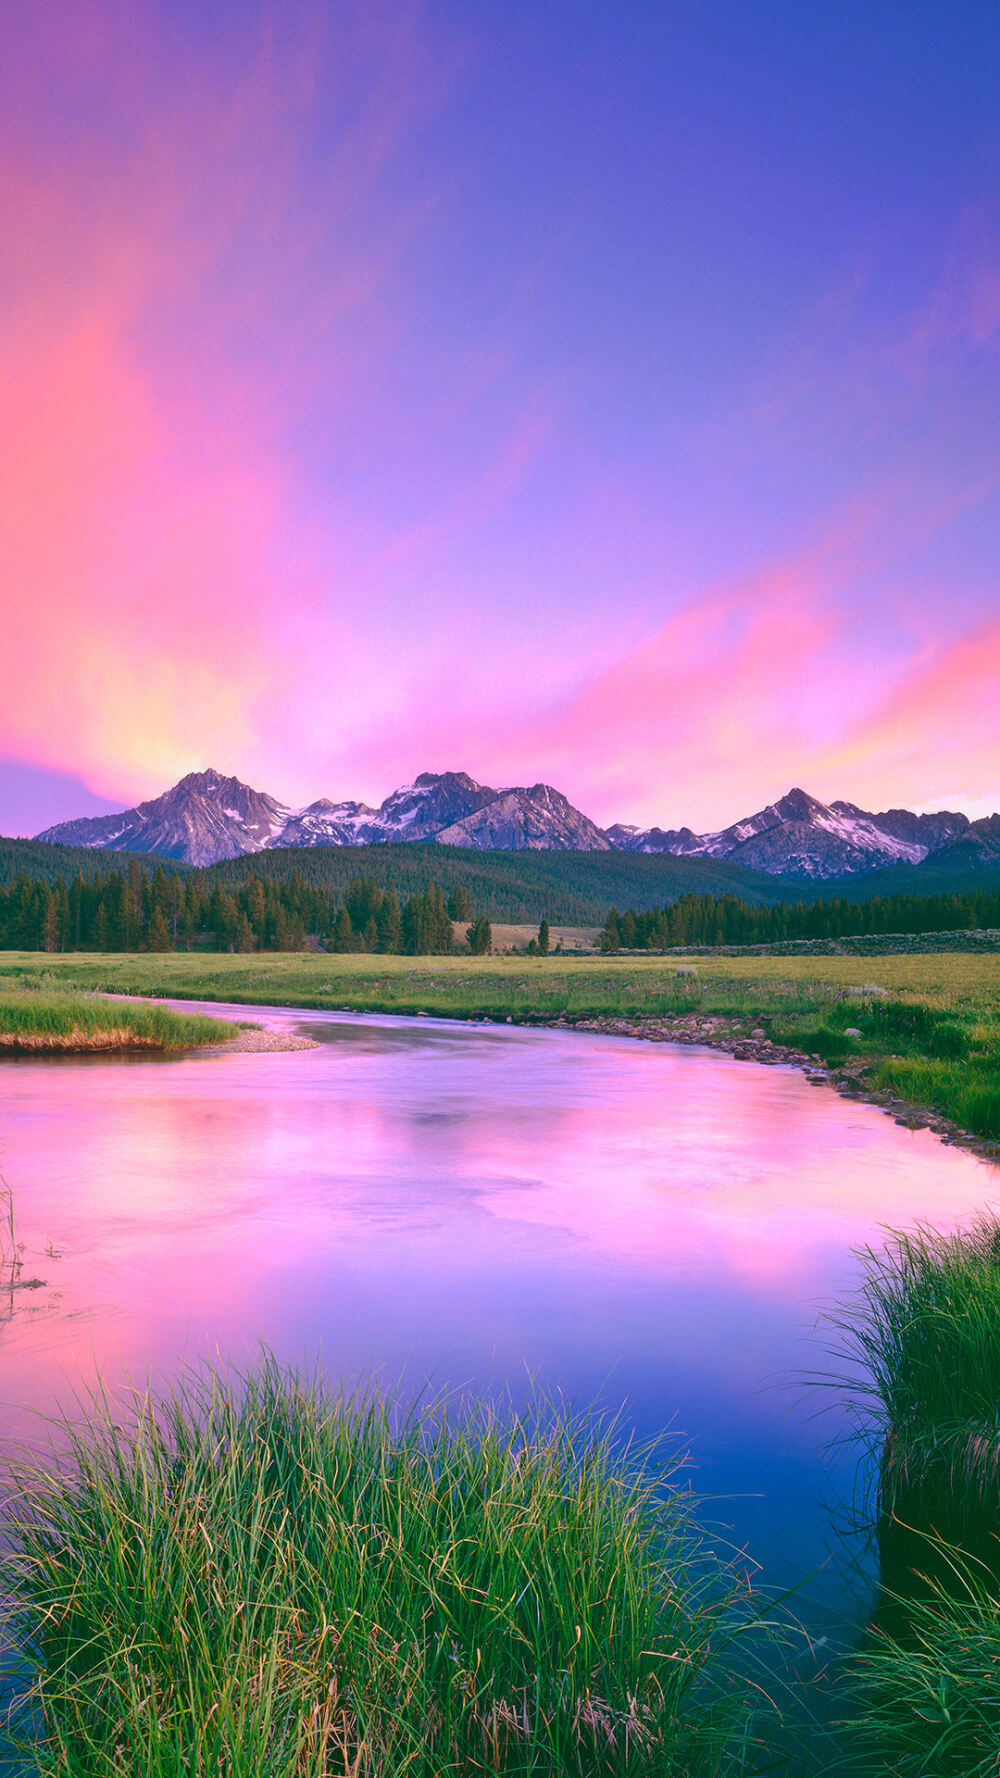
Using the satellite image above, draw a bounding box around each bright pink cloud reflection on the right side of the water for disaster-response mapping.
[473,1040,1000,1291]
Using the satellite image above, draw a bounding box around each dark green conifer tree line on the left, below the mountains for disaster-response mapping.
[0,859,493,957]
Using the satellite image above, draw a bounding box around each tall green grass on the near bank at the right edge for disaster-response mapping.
[835,1214,1000,1778]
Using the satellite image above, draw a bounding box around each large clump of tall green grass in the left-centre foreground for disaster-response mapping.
[4,1357,779,1778]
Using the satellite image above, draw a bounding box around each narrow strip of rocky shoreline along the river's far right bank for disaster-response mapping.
[544,1013,1000,1163]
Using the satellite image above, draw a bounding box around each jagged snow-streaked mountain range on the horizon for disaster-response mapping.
[36,768,1000,880]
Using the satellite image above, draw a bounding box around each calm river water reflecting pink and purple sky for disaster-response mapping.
[0,1006,998,1625]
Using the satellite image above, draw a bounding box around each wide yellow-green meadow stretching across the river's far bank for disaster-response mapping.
[0,951,1000,1140]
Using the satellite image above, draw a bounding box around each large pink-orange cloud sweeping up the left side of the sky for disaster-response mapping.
[0,5,454,795]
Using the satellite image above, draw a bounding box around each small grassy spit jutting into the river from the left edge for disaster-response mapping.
[0,978,235,1056]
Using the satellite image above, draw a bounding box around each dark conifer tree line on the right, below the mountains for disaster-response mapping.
[598,889,1000,951]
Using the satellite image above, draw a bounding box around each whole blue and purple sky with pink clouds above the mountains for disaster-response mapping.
[0,0,1000,834]
